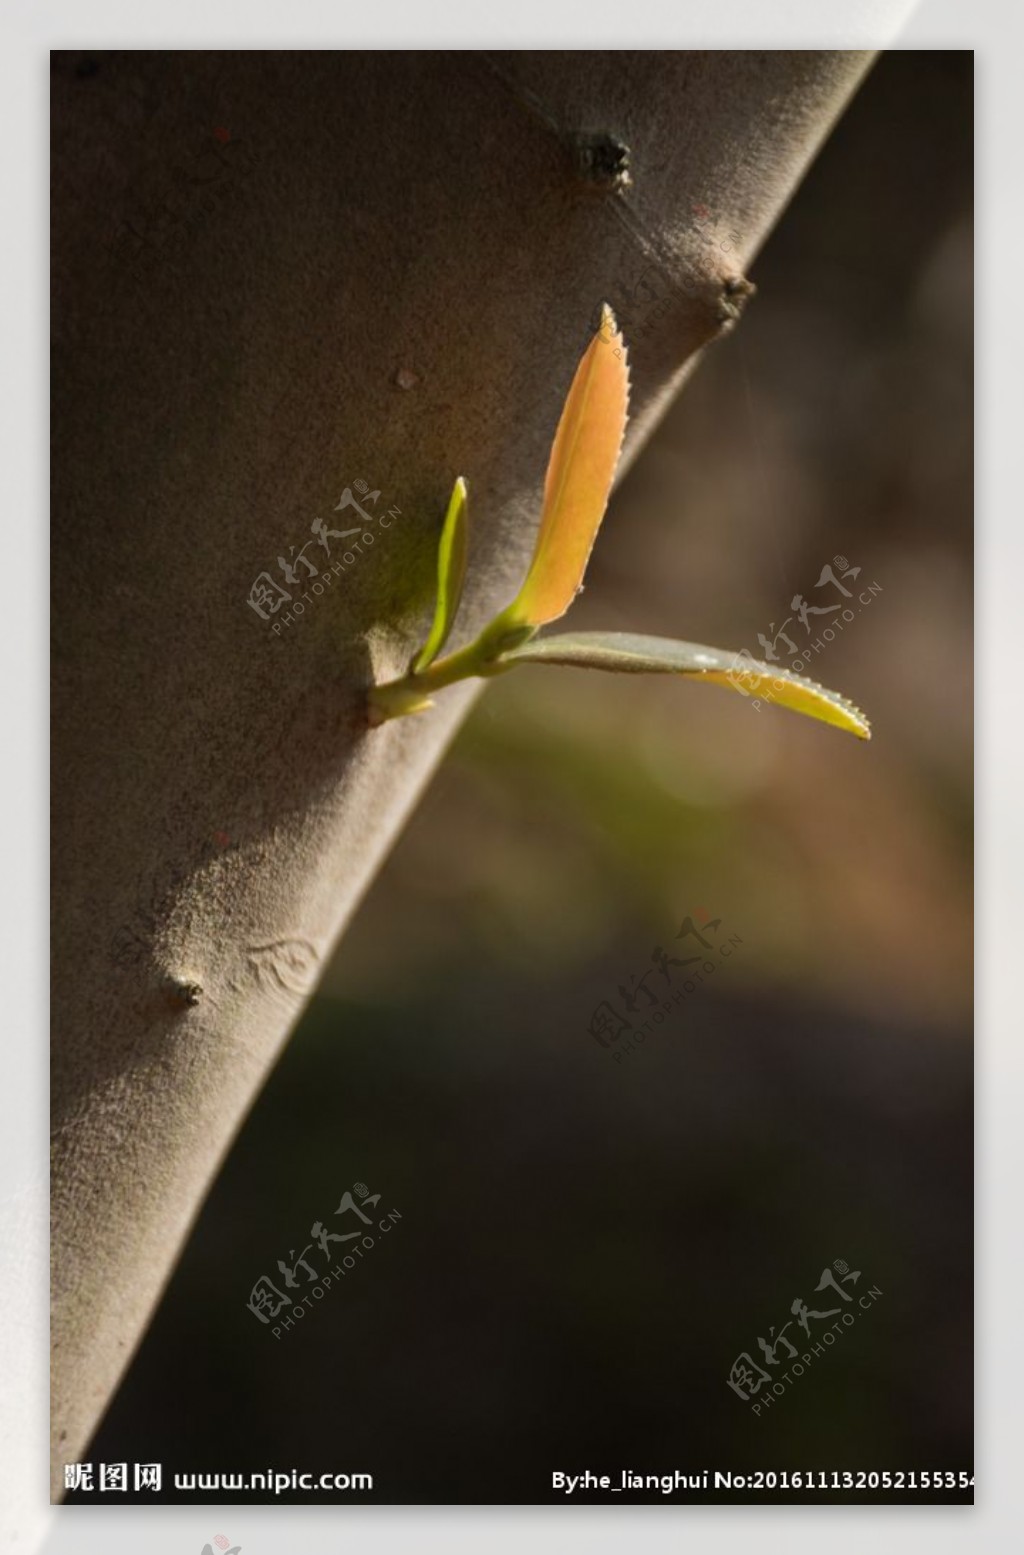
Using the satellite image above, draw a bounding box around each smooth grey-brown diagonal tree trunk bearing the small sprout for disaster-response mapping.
[53,42,870,1494]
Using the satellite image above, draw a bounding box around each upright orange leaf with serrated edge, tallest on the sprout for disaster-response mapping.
[497,303,629,627]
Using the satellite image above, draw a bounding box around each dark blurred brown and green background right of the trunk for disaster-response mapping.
[70,53,973,1504]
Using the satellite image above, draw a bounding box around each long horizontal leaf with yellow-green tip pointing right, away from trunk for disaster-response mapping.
[499,631,872,740]
